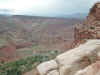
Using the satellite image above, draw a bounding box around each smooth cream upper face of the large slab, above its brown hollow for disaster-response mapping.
[56,40,100,66]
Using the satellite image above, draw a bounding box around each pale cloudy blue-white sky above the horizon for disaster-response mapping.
[0,0,99,16]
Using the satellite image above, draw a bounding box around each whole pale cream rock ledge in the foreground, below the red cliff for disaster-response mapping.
[37,40,100,75]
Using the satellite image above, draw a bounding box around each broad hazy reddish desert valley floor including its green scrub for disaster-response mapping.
[0,15,80,75]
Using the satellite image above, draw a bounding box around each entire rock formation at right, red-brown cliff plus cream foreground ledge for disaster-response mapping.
[37,2,100,75]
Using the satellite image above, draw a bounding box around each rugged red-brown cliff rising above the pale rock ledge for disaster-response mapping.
[72,2,100,48]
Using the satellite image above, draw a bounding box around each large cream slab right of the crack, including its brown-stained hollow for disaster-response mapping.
[56,40,100,75]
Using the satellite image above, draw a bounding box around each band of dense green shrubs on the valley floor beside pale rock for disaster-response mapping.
[0,51,58,75]
